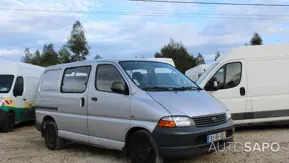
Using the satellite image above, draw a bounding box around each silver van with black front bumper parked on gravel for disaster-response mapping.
[36,59,234,163]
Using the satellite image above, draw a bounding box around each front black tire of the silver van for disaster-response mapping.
[128,130,163,163]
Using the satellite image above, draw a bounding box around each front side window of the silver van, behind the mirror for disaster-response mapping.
[95,64,125,92]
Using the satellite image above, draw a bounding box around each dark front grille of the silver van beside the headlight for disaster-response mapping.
[193,114,226,127]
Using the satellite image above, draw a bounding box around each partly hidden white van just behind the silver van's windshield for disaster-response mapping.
[185,64,211,82]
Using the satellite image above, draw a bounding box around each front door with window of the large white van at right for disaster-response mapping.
[205,61,252,123]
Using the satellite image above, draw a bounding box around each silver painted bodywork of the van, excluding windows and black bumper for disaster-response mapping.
[36,59,226,150]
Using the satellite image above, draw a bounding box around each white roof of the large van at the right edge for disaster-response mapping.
[218,43,289,62]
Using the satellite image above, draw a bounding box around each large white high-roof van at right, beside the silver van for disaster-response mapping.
[197,44,289,124]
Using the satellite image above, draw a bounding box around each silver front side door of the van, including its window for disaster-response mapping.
[88,63,131,149]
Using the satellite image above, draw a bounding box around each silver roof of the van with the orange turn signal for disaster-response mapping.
[47,58,170,69]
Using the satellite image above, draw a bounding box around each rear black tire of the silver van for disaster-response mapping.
[44,122,64,150]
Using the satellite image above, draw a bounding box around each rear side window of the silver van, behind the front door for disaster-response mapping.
[61,66,91,93]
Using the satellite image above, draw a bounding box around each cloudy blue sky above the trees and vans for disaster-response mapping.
[0,0,289,62]
